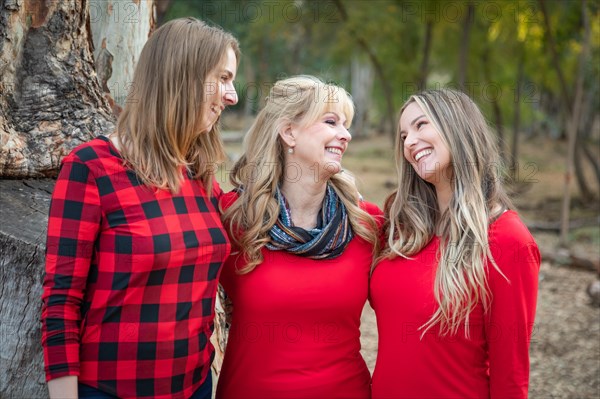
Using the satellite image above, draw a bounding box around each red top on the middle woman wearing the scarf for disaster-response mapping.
[217,193,381,399]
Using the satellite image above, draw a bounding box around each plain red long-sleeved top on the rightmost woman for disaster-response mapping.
[370,211,540,399]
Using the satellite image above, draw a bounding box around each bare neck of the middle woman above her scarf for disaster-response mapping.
[281,181,327,230]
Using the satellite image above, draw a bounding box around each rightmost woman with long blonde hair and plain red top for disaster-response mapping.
[370,89,540,399]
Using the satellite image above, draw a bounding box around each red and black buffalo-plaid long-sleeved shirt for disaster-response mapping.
[42,136,230,398]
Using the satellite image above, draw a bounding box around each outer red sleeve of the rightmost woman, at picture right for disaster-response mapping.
[485,238,540,399]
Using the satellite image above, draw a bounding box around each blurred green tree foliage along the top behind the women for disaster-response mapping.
[166,0,600,138]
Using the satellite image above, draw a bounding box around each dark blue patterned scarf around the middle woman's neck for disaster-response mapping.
[266,184,353,259]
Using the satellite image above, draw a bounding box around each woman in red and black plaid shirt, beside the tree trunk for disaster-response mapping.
[42,18,239,399]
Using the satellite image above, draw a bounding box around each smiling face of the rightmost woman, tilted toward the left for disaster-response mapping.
[400,102,453,190]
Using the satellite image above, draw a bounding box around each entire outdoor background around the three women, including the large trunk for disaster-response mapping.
[0,0,600,399]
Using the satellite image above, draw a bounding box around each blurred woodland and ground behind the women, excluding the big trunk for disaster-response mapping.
[162,0,600,399]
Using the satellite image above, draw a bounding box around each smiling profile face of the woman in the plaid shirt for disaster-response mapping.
[199,48,238,133]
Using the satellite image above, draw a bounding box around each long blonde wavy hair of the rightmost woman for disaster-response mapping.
[381,89,512,336]
